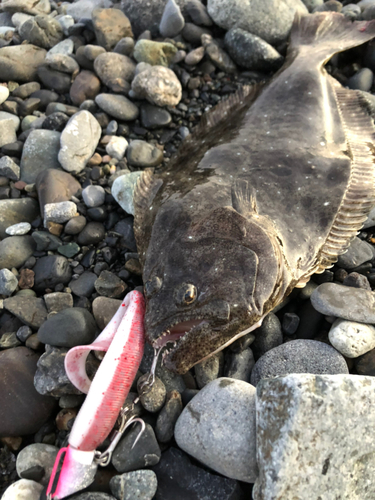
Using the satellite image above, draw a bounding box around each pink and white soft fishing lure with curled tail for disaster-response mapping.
[47,291,145,499]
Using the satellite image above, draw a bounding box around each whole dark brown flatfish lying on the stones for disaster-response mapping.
[133,12,375,374]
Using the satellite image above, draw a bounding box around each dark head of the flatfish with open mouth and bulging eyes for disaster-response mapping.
[144,207,282,373]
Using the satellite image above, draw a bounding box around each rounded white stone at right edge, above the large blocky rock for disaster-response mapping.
[328,319,375,358]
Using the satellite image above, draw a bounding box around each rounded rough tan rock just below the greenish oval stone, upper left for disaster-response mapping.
[132,66,182,106]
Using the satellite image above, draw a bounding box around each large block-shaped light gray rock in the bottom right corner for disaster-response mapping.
[253,374,375,500]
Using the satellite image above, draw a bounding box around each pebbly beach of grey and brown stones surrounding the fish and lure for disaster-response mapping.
[0,0,375,500]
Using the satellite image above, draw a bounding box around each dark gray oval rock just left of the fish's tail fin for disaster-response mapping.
[225,28,283,71]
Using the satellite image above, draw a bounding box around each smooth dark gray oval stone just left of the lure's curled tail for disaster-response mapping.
[38,307,97,347]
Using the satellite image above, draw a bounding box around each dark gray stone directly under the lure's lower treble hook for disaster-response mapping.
[112,424,161,473]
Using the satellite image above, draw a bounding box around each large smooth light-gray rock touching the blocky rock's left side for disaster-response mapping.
[175,377,258,483]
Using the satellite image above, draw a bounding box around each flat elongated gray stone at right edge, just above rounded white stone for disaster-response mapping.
[311,283,375,324]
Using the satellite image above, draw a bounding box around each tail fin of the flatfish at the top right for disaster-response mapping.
[289,12,375,64]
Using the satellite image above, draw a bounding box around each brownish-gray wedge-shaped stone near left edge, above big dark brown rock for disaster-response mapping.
[4,294,47,328]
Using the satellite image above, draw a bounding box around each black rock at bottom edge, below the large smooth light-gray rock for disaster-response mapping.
[153,447,243,500]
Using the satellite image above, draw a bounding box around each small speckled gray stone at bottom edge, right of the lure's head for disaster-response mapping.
[109,470,158,500]
